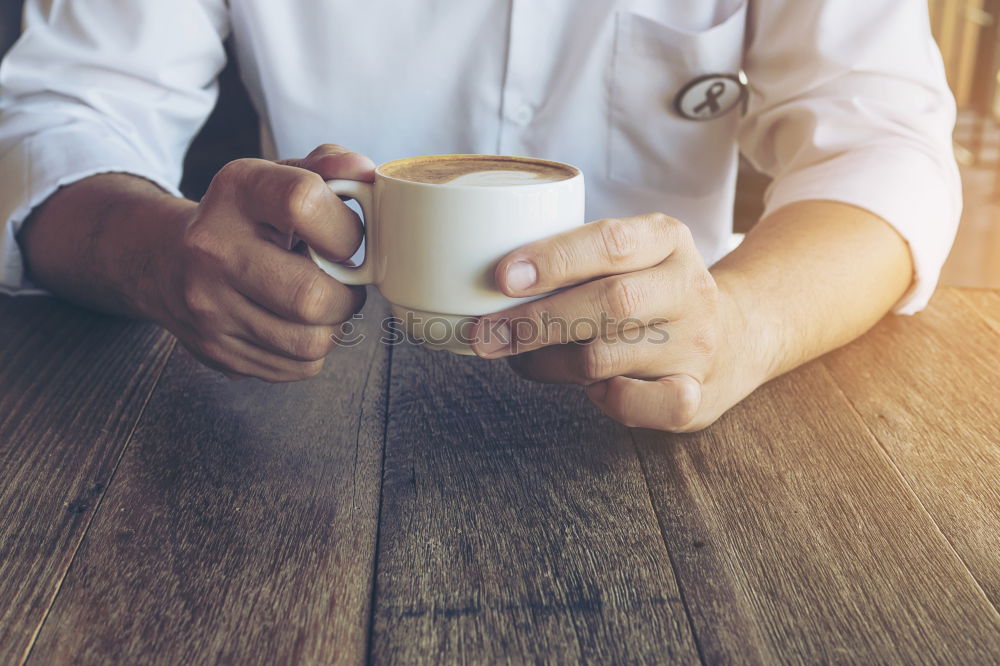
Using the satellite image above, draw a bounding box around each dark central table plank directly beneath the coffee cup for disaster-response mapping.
[372,346,698,664]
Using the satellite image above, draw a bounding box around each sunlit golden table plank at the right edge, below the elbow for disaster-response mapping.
[824,289,1000,605]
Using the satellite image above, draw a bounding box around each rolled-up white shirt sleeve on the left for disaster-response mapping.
[0,0,228,293]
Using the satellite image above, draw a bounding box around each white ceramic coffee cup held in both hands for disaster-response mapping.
[309,155,584,354]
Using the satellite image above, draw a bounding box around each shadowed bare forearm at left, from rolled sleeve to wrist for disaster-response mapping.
[18,174,196,317]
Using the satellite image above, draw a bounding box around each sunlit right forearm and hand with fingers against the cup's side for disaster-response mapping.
[474,201,913,432]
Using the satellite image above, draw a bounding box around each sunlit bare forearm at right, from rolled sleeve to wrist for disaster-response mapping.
[711,201,913,383]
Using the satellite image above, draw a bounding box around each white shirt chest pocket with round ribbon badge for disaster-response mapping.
[608,0,747,196]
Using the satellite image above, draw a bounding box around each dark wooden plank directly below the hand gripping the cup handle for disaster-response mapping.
[23,304,388,664]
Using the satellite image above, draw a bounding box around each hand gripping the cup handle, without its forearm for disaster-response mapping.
[152,146,374,382]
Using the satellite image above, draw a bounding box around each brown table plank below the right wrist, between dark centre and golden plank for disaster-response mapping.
[635,363,1000,664]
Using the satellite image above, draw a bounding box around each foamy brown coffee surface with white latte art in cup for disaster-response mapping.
[378,155,579,187]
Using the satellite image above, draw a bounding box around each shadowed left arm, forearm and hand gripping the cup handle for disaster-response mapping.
[18,146,375,381]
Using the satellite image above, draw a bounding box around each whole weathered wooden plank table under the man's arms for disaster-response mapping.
[0,289,1000,665]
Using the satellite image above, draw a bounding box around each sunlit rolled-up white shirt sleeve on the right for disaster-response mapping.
[740,0,962,314]
